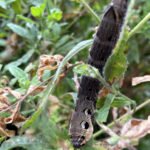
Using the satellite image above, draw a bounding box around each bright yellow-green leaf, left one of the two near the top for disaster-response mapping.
[30,4,45,17]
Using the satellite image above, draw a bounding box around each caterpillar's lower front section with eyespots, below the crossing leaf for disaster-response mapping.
[69,76,100,148]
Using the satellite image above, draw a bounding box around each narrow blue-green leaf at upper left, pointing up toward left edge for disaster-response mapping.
[7,23,33,40]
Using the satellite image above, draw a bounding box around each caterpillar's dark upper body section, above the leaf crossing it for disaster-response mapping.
[88,0,128,74]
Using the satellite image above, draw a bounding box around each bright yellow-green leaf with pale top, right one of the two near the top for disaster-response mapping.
[48,8,63,21]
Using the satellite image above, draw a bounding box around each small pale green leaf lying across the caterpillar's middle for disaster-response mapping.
[73,64,99,78]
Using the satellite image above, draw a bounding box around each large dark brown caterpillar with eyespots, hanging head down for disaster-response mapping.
[69,0,128,148]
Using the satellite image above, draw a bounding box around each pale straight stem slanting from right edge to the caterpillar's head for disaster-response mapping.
[93,99,150,138]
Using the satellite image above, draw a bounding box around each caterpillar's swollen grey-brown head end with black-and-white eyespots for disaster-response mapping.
[69,101,94,148]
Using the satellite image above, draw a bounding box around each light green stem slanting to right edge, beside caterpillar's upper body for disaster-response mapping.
[127,13,150,39]
